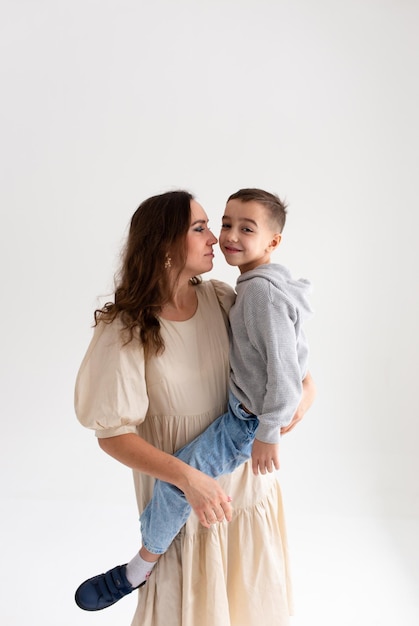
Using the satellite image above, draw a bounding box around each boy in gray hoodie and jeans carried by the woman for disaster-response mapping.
[76,189,312,611]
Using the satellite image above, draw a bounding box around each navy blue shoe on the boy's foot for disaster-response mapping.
[75,565,146,611]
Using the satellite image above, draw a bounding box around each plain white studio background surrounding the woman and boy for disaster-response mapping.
[0,0,419,626]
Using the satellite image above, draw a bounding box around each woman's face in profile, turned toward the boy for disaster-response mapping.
[182,200,217,279]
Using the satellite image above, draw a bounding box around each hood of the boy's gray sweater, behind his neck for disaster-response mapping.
[237,263,313,321]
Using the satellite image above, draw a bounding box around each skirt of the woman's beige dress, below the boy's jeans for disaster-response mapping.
[132,463,292,626]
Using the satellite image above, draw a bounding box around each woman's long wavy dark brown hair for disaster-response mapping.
[94,191,193,356]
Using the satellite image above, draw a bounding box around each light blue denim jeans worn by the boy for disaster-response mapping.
[140,393,259,554]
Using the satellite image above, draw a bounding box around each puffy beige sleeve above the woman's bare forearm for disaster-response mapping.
[74,320,148,437]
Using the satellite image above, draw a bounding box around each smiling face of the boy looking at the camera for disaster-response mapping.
[220,199,281,273]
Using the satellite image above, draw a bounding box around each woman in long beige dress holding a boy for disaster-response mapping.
[76,191,301,626]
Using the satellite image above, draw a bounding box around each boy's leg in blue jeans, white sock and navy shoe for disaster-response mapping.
[75,396,258,611]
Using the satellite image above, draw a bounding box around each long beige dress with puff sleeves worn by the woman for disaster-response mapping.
[75,281,291,626]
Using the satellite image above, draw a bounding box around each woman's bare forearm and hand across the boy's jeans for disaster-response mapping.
[99,433,232,528]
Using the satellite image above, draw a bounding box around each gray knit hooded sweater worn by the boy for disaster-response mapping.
[230,263,312,443]
